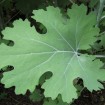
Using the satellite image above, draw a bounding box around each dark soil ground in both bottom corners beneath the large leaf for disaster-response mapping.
[0,84,105,105]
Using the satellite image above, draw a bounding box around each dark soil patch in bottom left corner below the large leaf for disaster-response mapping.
[0,84,42,105]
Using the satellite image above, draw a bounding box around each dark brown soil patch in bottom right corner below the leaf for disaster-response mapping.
[71,88,105,105]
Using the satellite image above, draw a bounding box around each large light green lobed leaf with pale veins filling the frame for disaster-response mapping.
[0,4,105,103]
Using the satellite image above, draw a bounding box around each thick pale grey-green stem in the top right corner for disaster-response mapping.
[97,0,105,26]
